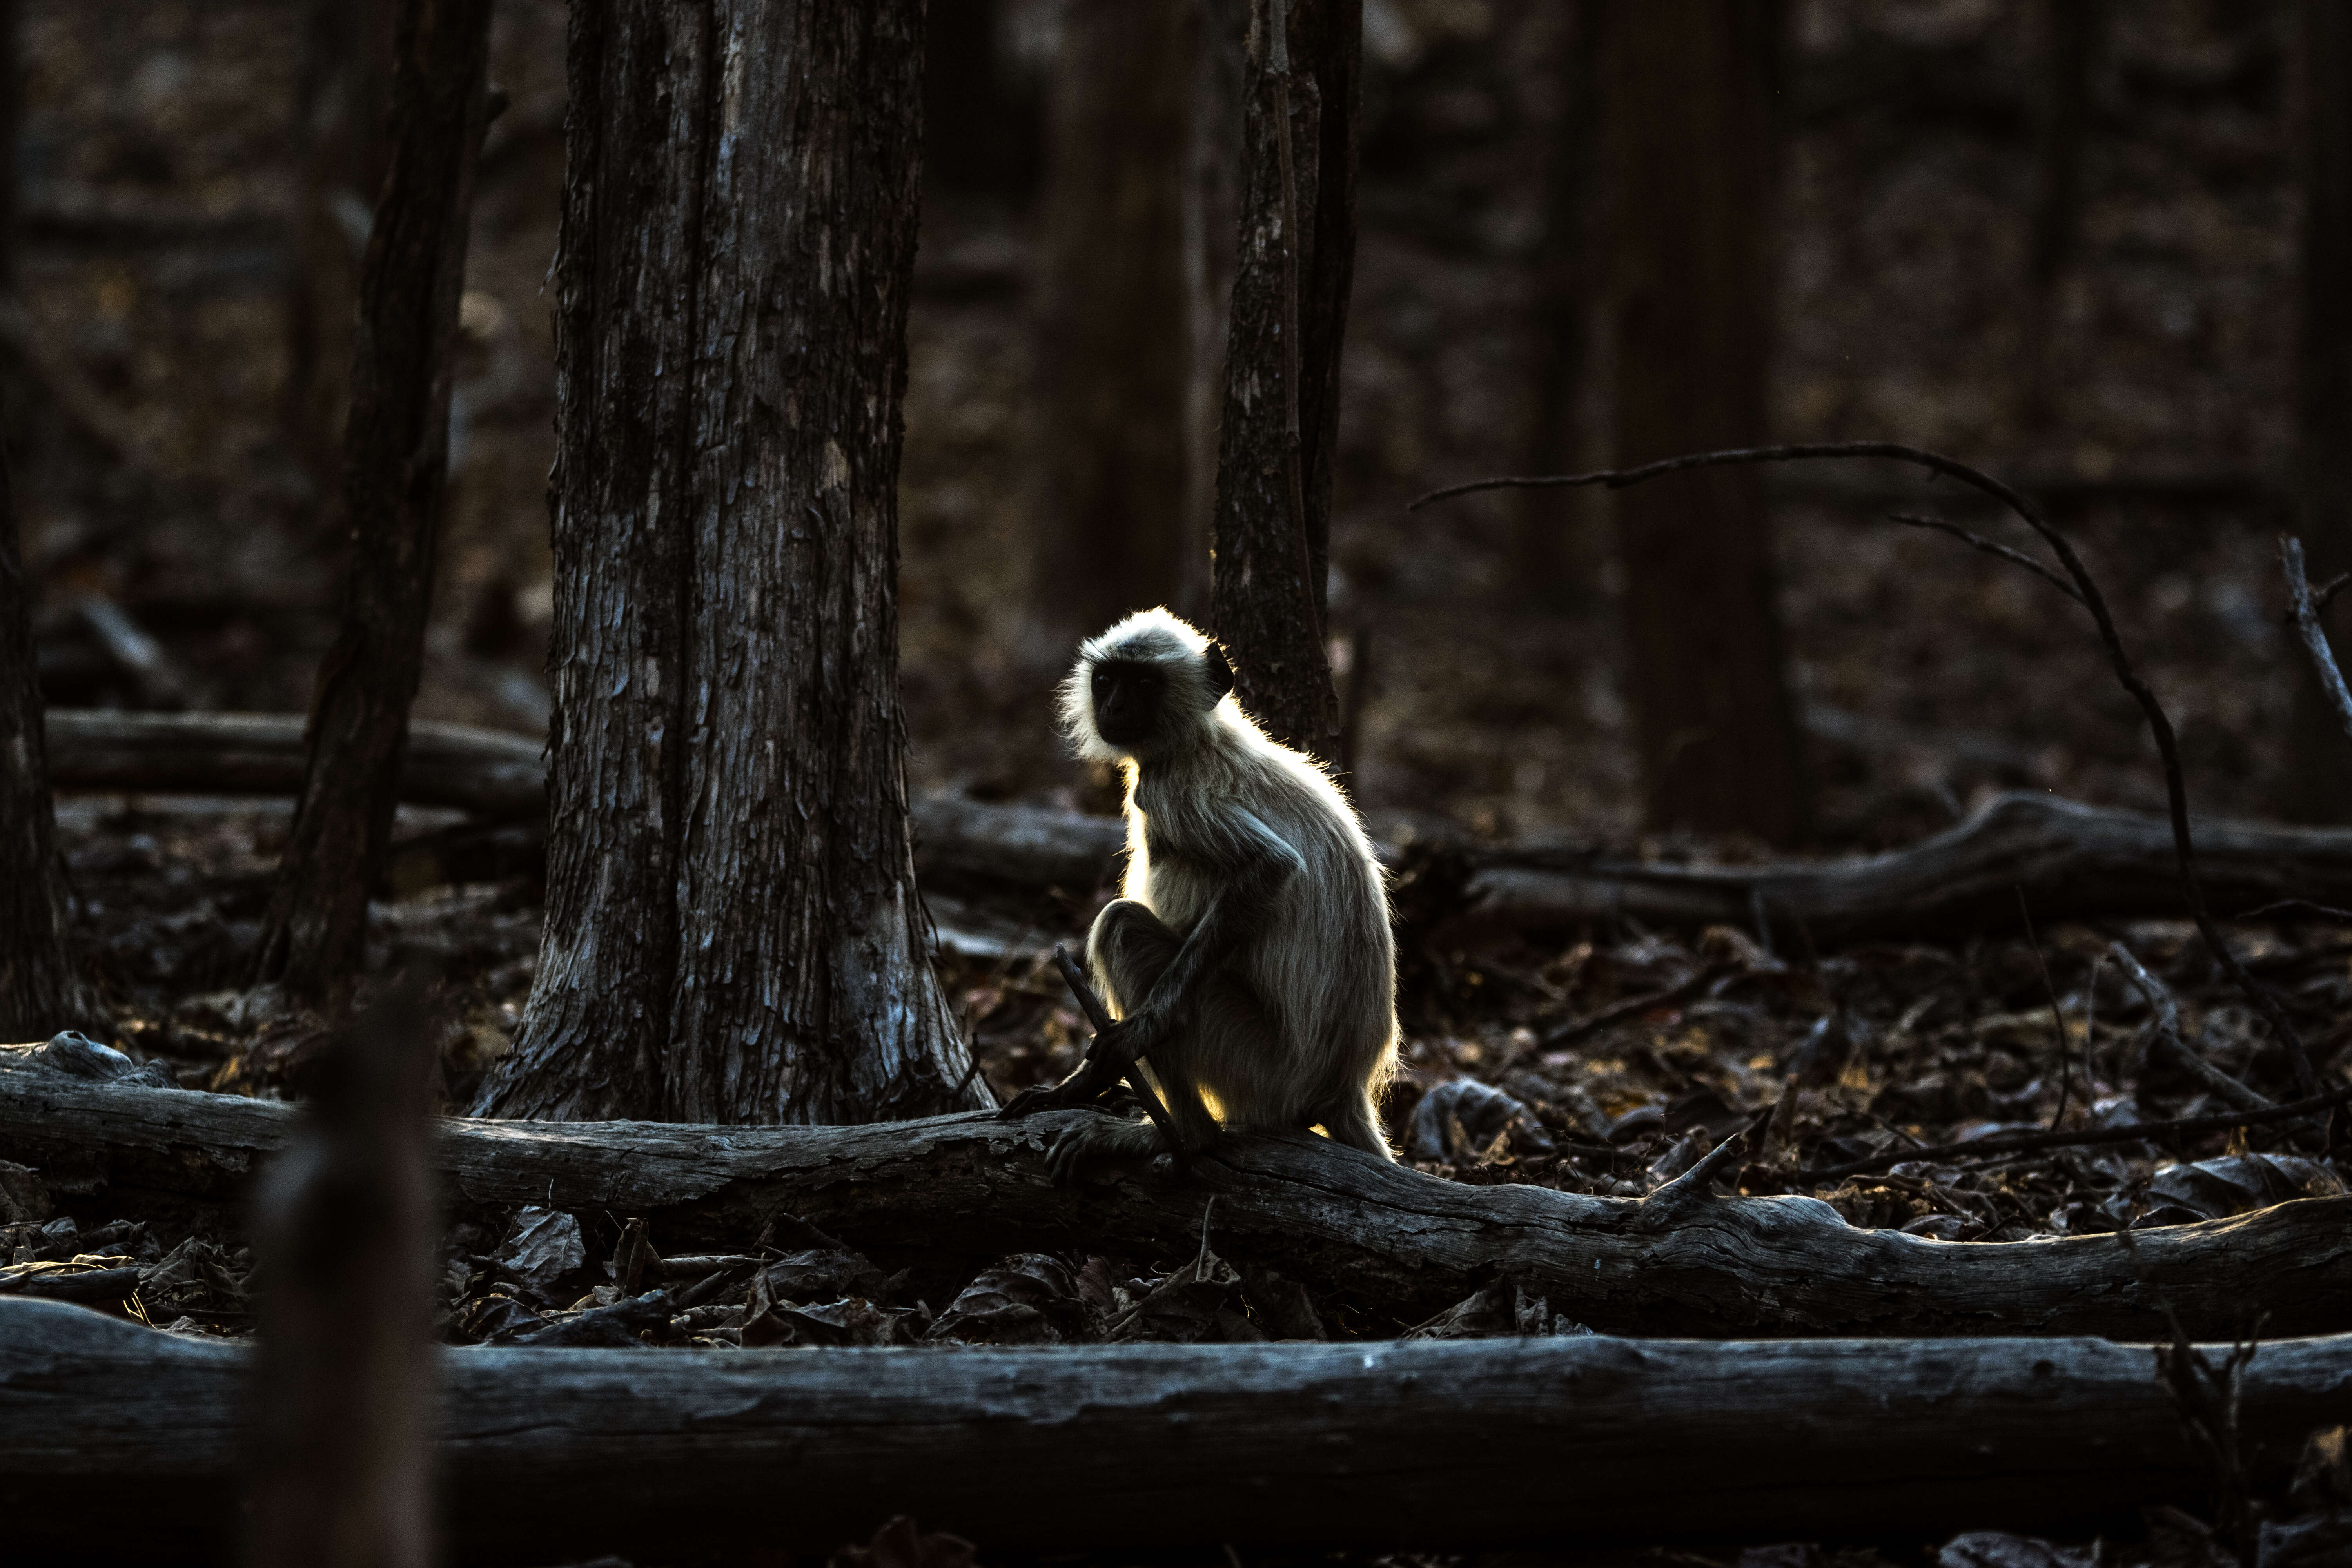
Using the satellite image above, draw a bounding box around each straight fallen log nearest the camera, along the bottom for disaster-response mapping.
[0,1302,2352,1563]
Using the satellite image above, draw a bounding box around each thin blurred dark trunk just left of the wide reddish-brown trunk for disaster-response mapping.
[1517,0,1602,611]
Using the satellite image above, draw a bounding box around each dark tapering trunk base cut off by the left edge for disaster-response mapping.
[0,416,92,1039]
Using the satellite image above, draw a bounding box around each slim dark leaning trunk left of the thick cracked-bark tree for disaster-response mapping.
[259,0,489,999]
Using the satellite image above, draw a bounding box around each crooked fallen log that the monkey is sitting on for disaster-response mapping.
[0,1046,2352,1338]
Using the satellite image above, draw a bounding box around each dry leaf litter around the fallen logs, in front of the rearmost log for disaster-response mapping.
[18,797,2352,1568]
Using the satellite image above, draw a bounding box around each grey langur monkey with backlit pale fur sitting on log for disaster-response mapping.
[1025,609,1397,1180]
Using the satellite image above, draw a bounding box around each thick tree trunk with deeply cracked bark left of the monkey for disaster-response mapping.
[480,0,985,1122]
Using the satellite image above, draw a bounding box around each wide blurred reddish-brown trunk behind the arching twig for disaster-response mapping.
[1602,0,1806,844]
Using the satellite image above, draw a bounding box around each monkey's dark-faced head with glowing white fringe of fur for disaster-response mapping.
[1061,609,1232,762]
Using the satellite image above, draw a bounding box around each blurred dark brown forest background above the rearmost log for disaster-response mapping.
[9,0,2338,849]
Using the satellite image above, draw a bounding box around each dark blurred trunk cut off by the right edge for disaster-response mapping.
[2281,0,2352,823]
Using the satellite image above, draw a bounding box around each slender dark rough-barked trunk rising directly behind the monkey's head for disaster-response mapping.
[1209,0,1364,757]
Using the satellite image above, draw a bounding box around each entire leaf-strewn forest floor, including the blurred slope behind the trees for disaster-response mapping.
[0,0,2352,1568]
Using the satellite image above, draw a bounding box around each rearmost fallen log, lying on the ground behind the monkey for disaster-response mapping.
[36,708,2352,945]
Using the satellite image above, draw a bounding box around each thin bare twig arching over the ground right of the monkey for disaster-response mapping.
[1406,442,2319,1096]
